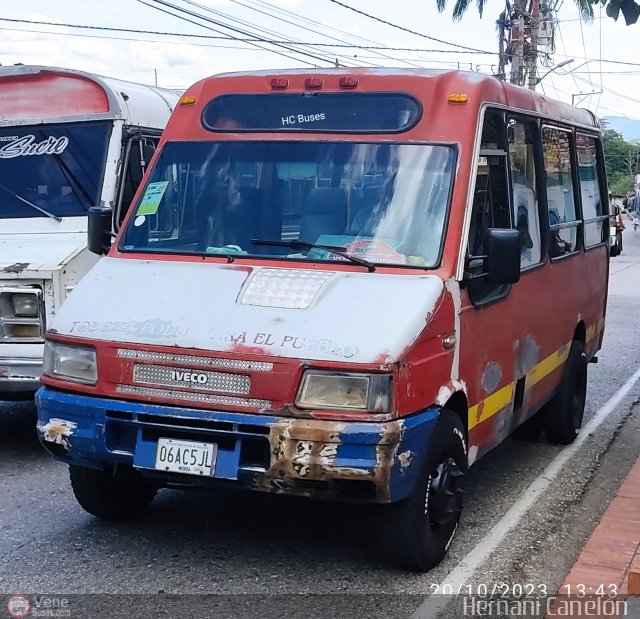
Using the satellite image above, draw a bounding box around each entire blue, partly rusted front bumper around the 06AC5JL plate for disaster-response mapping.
[36,387,438,503]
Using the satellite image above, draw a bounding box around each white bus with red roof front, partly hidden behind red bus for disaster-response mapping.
[0,65,179,400]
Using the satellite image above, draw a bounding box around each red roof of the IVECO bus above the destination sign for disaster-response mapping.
[181,68,600,129]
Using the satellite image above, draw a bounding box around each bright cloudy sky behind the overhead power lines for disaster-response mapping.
[0,0,640,119]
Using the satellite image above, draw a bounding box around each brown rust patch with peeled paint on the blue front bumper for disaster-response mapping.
[253,419,404,502]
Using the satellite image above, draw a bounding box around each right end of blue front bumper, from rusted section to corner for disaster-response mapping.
[253,410,437,503]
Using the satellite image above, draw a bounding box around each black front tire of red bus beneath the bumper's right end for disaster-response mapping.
[380,409,467,572]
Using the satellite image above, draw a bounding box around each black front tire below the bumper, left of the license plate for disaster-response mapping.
[69,466,158,520]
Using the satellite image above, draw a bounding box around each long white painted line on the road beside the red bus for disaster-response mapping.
[411,368,640,619]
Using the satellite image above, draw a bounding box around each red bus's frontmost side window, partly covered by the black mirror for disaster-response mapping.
[467,110,512,305]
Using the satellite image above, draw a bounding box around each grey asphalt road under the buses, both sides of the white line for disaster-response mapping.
[0,228,640,617]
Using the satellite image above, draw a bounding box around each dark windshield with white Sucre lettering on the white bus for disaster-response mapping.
[0,121,112,219]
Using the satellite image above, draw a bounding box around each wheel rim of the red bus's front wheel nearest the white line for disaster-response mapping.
[427,458,464,529]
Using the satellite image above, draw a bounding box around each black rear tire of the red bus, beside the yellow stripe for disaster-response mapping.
[545,340,587,445]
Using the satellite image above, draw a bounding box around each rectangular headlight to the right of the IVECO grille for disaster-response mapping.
[296,370,392,413]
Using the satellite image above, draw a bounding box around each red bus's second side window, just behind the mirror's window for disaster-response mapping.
[508,118,542,269]
